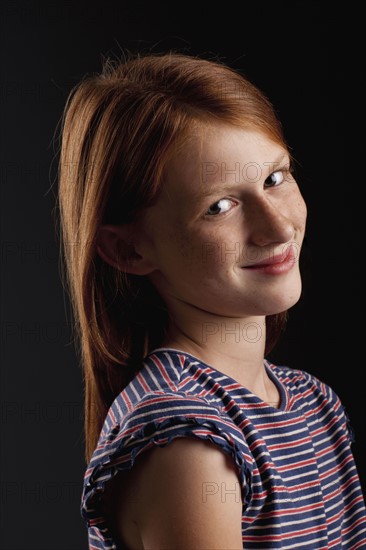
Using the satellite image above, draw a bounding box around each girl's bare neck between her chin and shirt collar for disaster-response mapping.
[161,303,279,404]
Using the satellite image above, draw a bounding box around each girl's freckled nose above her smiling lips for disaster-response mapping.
[245,195,295,246]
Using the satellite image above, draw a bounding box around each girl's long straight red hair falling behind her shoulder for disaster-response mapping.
[57,53,287,462]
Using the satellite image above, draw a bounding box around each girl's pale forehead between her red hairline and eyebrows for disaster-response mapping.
[164,124,288,194]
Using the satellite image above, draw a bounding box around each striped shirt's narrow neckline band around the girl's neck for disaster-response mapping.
[146,347,289,412]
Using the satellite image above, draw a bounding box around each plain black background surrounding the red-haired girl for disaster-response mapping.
[0,1,366,550]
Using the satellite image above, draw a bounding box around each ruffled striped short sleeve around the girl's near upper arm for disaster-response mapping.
[81,391,250,550]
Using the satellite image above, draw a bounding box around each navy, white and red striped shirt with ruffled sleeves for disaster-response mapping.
[81,348,366,550]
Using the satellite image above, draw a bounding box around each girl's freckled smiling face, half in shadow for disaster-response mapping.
[139,125,306,317]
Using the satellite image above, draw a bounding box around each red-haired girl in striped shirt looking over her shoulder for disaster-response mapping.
[59,53,366,550]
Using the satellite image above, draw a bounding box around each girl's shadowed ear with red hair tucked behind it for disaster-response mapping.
[97,224,155,275]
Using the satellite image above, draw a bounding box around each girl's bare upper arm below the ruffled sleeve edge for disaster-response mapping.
[117,438,243,550]
